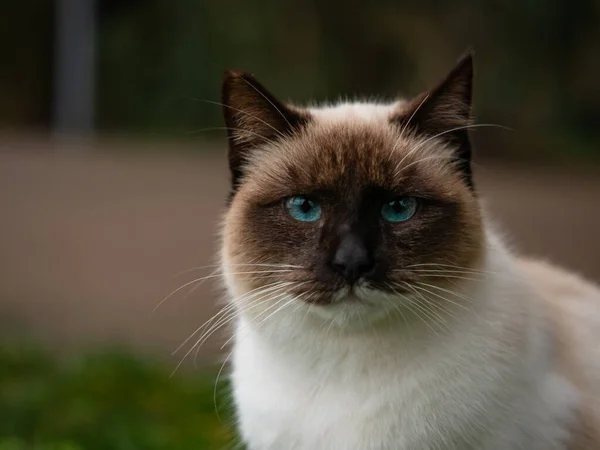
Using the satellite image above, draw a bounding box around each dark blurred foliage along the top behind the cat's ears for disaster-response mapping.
[0,0,600,157]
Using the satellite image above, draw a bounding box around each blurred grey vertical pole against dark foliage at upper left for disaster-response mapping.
[53,0,96,135]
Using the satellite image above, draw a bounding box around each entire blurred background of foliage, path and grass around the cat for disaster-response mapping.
[0,0,600,450]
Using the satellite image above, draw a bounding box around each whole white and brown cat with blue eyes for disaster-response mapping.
[221,52,600,450]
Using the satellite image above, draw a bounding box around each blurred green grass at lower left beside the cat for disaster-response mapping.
[0,346,239,450]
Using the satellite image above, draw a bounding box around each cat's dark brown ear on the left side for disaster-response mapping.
[221,71,310,191]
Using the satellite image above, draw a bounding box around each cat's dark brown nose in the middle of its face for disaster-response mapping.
[331,234,374,283]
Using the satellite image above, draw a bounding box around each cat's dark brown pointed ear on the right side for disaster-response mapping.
[392,50,473,186]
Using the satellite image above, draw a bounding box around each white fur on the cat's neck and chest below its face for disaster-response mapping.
[228,229,592,450]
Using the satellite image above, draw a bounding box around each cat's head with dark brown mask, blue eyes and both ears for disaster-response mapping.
[222,53,483,326]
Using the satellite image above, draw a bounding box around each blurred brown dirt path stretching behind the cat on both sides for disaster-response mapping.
[0,137,600,362]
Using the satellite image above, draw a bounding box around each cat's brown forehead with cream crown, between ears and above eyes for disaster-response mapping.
[240,103,461,202]
